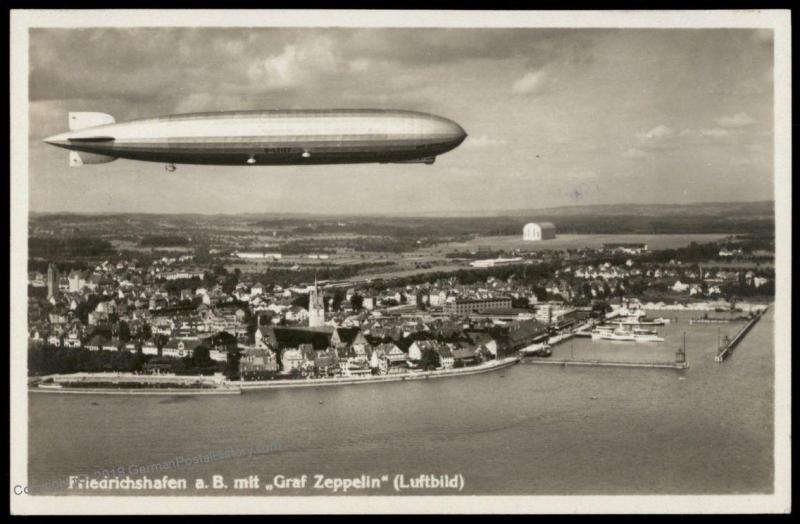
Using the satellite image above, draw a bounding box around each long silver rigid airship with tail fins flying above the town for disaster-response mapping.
[44,109,467,171]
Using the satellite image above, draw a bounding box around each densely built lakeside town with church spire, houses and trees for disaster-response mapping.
[28,210,774,381]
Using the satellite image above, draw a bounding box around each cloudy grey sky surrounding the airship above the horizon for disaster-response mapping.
[29,28,773,215]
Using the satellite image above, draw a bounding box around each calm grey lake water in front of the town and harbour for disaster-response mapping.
[29,311,774,495]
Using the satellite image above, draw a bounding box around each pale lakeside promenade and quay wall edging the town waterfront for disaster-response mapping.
[28,356,520,396]
